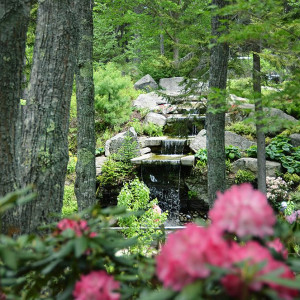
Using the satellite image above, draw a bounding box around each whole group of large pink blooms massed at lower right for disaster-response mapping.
[156,184,298,300]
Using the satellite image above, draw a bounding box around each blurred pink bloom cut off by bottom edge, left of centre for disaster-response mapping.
[73,271,120,300]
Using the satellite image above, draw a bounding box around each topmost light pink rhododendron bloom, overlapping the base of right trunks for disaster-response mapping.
[209,183,276,237]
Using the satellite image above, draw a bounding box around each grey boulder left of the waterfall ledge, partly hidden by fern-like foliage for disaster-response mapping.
[105,127,140,156]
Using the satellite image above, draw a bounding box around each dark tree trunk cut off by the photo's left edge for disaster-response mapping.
[0,0,30,233]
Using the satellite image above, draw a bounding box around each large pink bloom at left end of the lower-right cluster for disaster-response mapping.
[156,224,229,291]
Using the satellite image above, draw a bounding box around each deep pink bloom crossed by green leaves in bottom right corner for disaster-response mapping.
[221,241,297,300]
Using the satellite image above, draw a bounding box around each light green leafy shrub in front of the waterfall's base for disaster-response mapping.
[118,178,167,254]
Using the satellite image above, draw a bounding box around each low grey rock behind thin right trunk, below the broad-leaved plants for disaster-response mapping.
[232,157,281,177]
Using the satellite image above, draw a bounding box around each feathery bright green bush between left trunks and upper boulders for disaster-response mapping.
[94,63,138,126]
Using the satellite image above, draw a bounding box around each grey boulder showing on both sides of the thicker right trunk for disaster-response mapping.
[190,129,255,153]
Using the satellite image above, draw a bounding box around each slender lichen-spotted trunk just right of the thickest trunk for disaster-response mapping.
[75,0,96,211]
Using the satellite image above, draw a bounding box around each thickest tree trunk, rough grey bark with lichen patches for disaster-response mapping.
[20,0,77,232]
